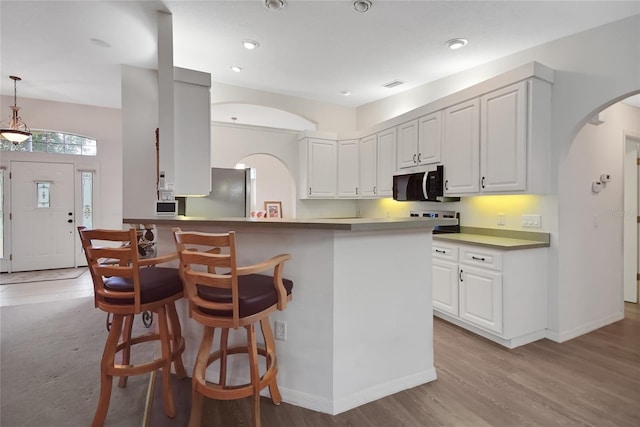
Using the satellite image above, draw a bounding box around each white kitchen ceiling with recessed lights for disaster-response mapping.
[0,0,640,112]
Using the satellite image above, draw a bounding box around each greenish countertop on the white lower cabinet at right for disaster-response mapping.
[433,226,550,250]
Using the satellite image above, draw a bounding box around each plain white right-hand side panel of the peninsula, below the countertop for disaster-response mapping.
[333,230,436,413]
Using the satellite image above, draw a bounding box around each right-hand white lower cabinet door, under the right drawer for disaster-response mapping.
[458,265,502,333]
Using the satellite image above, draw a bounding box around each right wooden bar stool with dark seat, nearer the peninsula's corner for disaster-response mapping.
[173,228,293,427]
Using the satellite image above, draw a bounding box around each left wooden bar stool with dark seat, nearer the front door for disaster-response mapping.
[78,227,186,427]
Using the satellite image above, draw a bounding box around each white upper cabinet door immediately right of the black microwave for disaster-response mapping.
[442,98,480,195]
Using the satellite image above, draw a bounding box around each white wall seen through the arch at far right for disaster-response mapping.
[558,103,640,340]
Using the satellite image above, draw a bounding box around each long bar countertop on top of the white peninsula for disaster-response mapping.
[122,215,456,231]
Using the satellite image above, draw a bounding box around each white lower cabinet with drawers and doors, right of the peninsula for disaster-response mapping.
[432,240,547,348]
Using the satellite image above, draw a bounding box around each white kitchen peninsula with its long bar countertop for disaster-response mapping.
[123,217,454,414]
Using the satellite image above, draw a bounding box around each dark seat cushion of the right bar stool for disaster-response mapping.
[197,274,293,317]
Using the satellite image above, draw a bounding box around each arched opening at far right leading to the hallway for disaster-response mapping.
[558,96,640,332]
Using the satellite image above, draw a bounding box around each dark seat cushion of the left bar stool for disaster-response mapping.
[104,267,183,304]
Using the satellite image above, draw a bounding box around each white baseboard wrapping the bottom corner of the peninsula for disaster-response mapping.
[272,368,437,415]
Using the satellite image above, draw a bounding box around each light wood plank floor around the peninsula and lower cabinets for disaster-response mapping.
[198,304,640,427]
